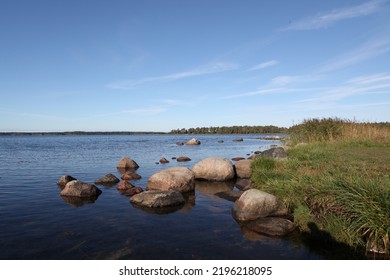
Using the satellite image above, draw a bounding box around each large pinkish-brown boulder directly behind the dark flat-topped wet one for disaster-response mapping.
[146,167,195,192]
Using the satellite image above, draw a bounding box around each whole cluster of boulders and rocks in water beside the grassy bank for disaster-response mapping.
[57,144,294,236]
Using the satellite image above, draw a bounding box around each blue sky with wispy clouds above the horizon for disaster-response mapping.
[0,0,390,131]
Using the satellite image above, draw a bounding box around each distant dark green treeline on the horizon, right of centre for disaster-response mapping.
[170,125,288,134]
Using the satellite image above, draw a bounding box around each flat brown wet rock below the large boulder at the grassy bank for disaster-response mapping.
[245,217,295,236]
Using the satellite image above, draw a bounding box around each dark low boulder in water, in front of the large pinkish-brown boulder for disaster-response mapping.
[130,190,185,208]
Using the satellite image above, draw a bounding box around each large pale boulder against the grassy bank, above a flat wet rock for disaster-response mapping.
[233,189,288,221]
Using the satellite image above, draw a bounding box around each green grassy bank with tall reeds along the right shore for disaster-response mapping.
[252,119,390,257]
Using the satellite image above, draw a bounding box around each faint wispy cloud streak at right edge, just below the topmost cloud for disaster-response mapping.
[320,38,390,72]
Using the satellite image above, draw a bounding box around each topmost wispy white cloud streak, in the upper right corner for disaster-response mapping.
[283,0,384,30]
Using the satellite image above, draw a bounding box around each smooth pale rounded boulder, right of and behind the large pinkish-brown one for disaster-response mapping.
[192,158,235,181]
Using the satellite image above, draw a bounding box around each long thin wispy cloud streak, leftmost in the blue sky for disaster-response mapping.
[106,62,238,90]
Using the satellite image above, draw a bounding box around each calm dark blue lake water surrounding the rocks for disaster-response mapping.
[0,135,322,259]
